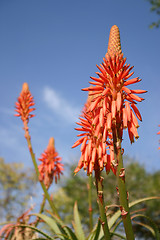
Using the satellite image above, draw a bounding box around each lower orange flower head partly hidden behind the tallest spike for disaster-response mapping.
[72,97,116,174]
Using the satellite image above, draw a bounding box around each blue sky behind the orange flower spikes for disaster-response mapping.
[0,0,160,170]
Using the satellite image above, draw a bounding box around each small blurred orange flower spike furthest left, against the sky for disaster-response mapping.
[15,83,35,123]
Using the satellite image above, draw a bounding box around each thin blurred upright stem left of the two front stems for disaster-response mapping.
[88,174,93,231]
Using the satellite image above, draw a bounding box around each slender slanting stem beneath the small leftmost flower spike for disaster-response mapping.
[24,122,60,218]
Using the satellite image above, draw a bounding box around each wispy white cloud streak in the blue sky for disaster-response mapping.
[43,87,81,123]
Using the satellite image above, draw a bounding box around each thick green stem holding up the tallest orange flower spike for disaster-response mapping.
[112,126,135,240]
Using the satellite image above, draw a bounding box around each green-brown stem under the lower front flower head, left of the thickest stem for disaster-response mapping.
[95,171,111,240]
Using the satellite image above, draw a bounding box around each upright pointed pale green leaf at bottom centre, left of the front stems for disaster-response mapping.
[73,202,85,240]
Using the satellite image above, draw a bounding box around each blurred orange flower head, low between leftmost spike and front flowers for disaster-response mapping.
[38,137,63,189]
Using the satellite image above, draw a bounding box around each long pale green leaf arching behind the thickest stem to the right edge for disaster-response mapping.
[107,197,160,229]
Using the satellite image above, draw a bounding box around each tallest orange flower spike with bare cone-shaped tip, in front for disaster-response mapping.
[82,25,146,143]
